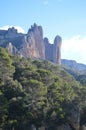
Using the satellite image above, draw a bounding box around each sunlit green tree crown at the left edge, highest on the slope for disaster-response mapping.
[0,48,15,83]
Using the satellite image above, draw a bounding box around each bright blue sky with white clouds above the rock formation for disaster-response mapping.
[0,0,86,64]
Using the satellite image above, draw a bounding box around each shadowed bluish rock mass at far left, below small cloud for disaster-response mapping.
[0,27,24,49]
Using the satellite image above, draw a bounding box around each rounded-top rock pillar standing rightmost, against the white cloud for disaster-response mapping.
[53,36,62,65]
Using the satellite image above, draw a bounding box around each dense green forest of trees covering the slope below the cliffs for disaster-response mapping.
[0,48,86,130]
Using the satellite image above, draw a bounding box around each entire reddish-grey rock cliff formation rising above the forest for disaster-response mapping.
[0,24,62,64]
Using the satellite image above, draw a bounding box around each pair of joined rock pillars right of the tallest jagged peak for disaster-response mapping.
[44,36,62,65]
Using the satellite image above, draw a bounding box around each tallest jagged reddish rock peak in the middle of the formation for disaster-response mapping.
[20,24,45,59]
